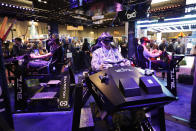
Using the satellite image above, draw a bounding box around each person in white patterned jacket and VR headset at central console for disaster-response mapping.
[91,32,130,71]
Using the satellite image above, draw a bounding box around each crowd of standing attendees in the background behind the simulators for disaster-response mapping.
[3,34,196,71]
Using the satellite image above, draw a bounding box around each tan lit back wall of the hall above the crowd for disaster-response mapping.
[0,17,125,40]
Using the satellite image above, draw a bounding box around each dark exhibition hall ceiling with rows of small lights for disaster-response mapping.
[0,0,188,28]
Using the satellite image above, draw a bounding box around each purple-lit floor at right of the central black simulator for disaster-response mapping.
[159,78,196,131]
